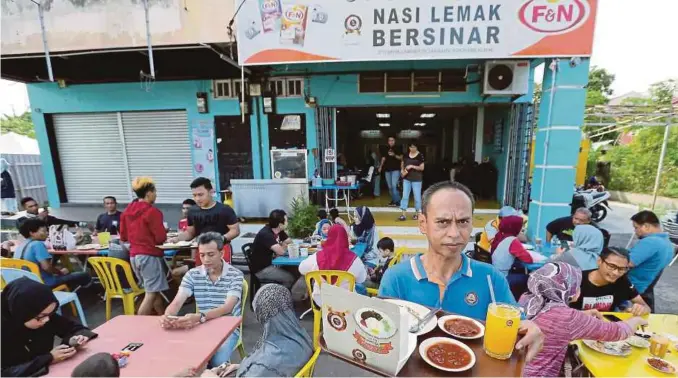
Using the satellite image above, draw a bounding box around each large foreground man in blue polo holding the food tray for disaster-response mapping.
[379,181,544,361]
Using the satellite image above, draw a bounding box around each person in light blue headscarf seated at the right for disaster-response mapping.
[553,224,604,270]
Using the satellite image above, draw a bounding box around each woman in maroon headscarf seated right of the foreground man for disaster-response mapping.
[490,215,546,299]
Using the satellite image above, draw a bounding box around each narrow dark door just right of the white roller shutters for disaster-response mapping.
[214,116,253,190]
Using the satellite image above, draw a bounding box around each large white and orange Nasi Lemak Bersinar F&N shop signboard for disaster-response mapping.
[235,0,597,65]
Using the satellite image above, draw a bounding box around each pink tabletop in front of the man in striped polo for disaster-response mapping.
[48,315,241,377]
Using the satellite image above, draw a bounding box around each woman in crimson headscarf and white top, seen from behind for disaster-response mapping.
[299,224,367,306]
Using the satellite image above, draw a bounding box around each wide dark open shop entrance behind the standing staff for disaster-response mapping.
[337,106,510,207]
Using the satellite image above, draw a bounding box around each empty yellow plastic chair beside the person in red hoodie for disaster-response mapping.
[88,257,146,321]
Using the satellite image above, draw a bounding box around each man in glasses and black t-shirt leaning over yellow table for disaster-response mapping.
[570,247,650,316]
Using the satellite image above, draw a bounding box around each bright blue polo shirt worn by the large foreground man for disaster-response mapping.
[379,253,516,321]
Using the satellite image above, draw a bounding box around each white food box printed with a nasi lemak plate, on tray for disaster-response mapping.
[321,285,416,376]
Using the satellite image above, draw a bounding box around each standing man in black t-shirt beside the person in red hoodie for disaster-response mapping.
[174,177,240,265]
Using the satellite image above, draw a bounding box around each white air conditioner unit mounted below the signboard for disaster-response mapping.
[483,60,530,96]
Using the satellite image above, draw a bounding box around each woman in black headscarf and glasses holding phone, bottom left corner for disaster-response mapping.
[0,277,97,377]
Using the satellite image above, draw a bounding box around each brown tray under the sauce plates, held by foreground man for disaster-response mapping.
[321,312,524,377]
